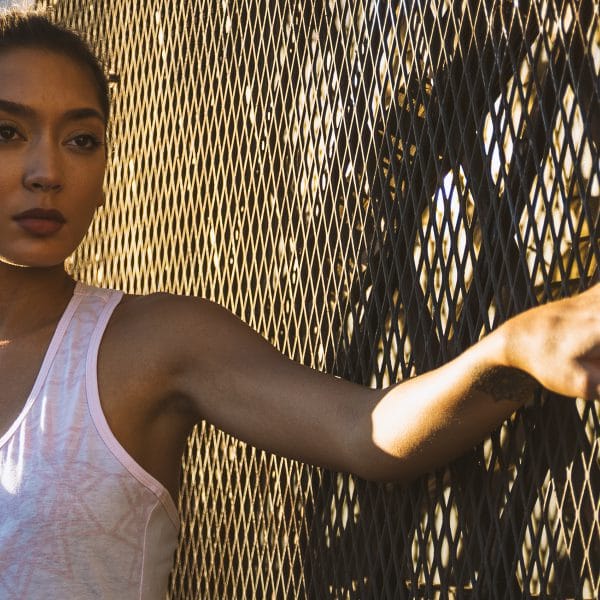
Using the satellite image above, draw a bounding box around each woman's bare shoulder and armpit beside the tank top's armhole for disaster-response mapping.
[98,294,237,497]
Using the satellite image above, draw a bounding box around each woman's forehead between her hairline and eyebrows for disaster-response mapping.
[0,48,103,118]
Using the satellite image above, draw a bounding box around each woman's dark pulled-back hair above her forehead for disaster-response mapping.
[0,9,110,123]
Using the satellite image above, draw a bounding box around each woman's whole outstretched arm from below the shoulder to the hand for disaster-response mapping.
[151,286,600,481]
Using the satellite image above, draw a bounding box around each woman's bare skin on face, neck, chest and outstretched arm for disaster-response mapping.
[0,49,600,496]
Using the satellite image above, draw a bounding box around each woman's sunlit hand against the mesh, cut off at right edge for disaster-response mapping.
[500,284,600,400]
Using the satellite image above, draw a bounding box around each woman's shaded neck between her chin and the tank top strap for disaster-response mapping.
[0,262,74,342]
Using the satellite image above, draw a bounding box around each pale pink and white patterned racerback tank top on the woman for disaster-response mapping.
[0,283,179,600]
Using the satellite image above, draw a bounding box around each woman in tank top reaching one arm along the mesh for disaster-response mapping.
[0,13,600,598]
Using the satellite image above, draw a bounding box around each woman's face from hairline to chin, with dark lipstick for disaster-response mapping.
[0,48,106,267]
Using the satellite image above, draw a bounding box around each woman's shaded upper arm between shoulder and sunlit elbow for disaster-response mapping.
[146,294,373,470]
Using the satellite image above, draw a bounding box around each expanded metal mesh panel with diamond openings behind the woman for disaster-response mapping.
[38,0,600,599]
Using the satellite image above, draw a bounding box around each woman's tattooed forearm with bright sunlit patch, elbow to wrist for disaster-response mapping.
[356,330,537,482]
